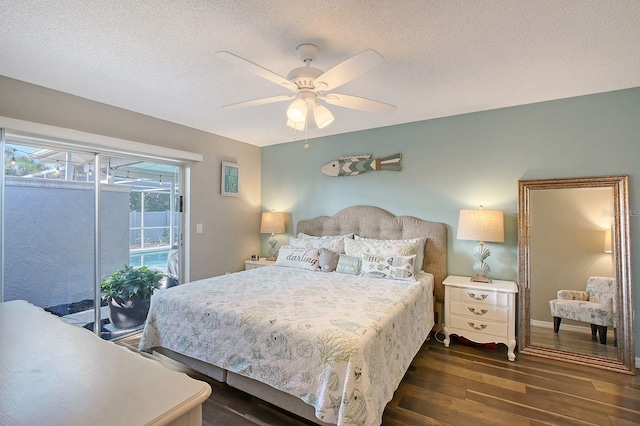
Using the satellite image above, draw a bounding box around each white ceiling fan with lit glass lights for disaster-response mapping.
[215,43,396,130]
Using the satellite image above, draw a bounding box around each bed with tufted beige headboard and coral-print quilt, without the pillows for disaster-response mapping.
[140,206,447,425]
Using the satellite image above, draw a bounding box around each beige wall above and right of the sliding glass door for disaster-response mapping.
[0,76,261,280]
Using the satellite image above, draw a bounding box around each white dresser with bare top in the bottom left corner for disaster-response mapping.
[0,300,211,426]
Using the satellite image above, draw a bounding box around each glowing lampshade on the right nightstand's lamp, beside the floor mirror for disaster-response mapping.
[457,208,504,243]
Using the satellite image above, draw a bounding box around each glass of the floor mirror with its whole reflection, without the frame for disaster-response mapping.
[529,188,617,359]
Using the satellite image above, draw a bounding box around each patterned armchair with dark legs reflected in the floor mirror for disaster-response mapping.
[549,277,616,345]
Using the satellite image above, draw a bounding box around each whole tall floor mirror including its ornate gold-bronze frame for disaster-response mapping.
[518,176,635,374]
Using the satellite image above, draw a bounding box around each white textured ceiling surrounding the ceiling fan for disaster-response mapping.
[0,0,640,146]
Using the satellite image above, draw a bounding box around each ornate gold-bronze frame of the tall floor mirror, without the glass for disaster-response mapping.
[518,175,636,374]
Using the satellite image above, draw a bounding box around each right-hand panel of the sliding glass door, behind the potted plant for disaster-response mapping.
[100,156,181,338]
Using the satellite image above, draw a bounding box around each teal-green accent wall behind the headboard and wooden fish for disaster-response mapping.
[261,88,640,355]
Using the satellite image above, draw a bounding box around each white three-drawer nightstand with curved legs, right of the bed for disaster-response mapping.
[442,275,518,361]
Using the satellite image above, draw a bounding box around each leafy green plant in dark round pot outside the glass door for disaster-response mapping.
[100,265,164,328]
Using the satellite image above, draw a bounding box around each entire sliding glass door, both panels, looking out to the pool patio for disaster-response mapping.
[0,130,181,339]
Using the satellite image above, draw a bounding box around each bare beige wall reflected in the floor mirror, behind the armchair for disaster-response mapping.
[530,188,614,326]
